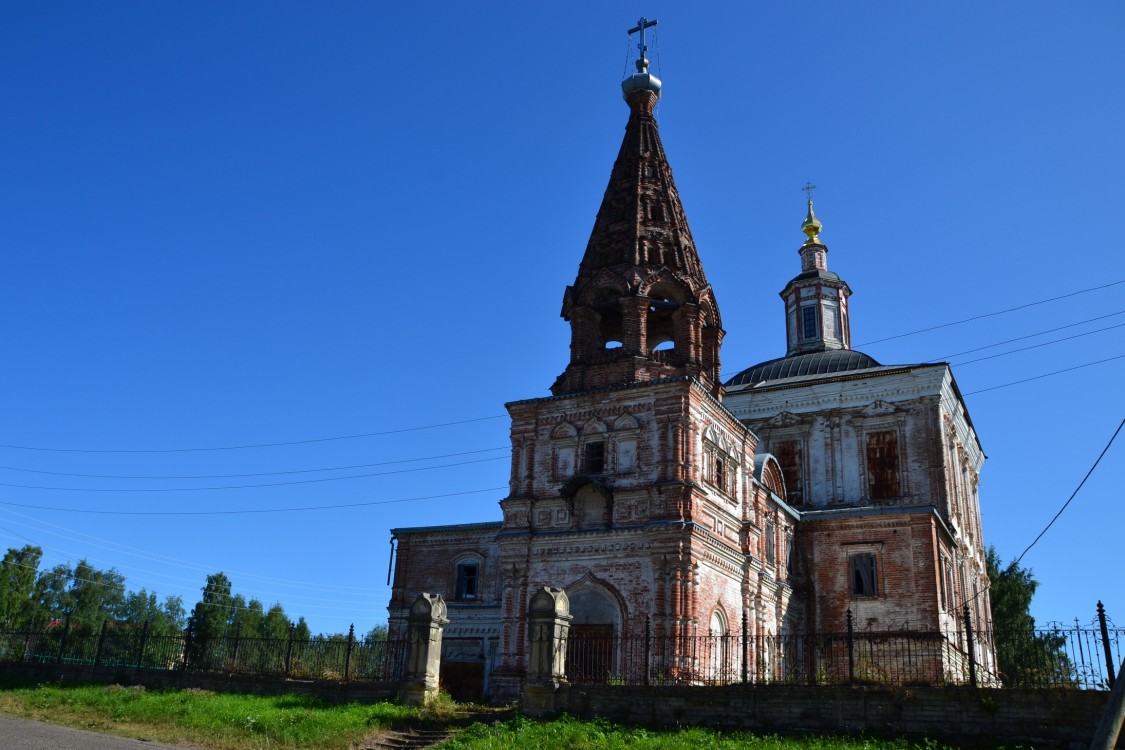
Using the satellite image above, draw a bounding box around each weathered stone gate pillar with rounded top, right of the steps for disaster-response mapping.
[522,586,573,716]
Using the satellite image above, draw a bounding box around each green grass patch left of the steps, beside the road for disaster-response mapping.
[0,685,420,750]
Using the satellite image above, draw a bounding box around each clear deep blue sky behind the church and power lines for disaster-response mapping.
[0,1,1125,632]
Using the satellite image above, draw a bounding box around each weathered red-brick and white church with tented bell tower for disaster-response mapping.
[388,33,992,702]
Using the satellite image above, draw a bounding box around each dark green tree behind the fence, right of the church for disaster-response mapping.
[986,546,1072,687]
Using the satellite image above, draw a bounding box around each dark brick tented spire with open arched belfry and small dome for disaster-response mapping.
[551,59,723,396]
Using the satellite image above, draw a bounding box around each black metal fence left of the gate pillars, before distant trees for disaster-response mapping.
[0,623,408,681]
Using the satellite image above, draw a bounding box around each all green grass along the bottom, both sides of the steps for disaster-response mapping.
[0,677,1030,750]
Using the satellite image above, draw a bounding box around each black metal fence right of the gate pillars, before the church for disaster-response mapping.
[566,611,1125,689]
